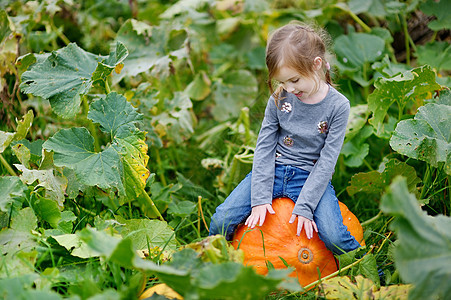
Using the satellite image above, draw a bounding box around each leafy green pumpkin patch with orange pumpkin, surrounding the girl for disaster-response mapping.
[0,0,451,300]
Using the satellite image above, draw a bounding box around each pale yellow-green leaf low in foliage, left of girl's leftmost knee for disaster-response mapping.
[119,219,177,250]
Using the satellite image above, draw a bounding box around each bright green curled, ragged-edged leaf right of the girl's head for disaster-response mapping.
[368,66,440,136]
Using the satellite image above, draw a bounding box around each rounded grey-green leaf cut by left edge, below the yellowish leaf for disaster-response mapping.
[0,176,27,212]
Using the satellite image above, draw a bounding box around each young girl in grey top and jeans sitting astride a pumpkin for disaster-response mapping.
[210,24,360,254]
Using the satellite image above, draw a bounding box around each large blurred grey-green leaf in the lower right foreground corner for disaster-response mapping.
[381,177,451,300]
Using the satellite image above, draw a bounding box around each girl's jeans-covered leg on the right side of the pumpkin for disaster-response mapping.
[313,183,360,254]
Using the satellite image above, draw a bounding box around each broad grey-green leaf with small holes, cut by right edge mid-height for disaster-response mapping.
[390,91,451,174]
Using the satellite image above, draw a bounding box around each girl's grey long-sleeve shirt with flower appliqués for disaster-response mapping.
[251,86,350,220]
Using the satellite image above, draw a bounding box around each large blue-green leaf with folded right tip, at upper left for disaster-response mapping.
[20,42,128,118]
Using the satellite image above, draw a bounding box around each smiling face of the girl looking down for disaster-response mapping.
[274,66,320,102]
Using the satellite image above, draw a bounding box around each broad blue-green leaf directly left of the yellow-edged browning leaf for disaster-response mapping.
[42,128,125,195]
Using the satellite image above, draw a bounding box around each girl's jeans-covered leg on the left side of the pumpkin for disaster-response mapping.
[209,173,252,241]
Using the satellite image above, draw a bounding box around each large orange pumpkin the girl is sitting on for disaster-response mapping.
[232,198,364,286]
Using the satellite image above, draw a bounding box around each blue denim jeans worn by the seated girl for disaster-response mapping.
[210,165,360,254]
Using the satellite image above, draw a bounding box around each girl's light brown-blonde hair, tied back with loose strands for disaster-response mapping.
[266,22,332,100]
